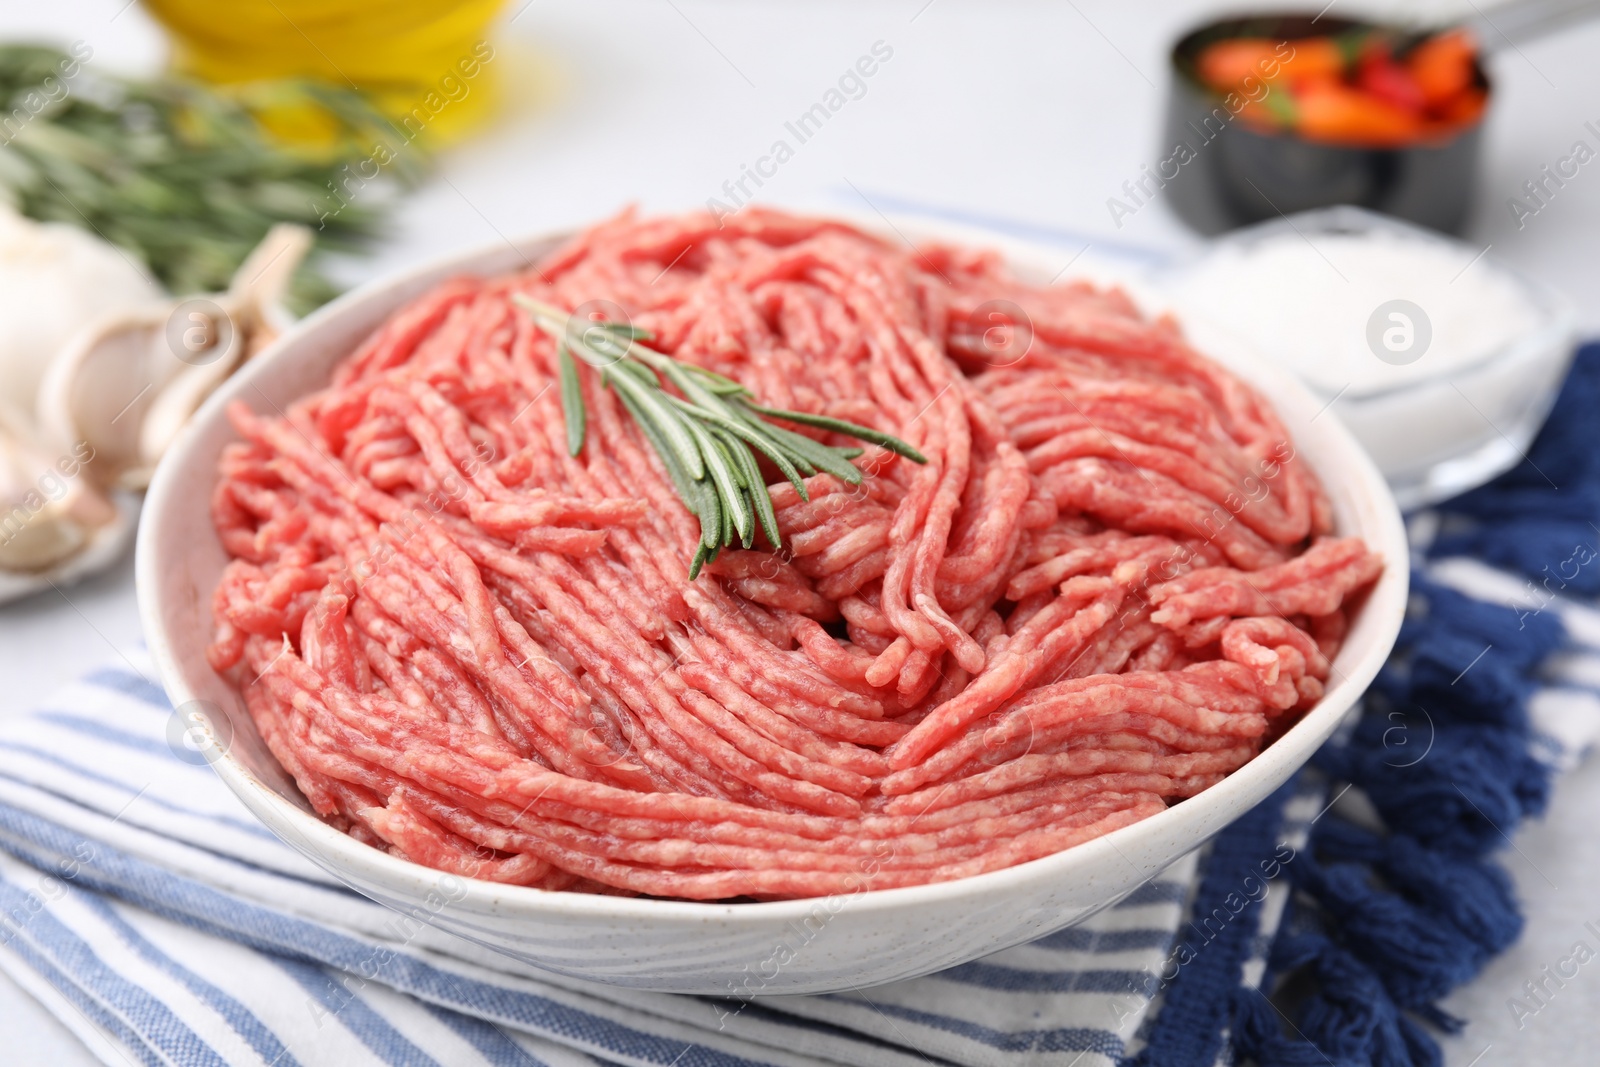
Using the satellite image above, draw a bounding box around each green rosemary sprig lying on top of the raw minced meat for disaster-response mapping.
[512,293,928,581]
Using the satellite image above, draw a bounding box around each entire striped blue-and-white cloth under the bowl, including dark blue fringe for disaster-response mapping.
[0,346,1600,1067]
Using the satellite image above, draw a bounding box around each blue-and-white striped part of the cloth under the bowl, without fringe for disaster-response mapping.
[0,656,1198,1067]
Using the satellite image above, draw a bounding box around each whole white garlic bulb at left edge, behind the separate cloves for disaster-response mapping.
[0,203,165,427]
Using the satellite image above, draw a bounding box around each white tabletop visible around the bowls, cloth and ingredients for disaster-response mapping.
[9,0,1600,1067]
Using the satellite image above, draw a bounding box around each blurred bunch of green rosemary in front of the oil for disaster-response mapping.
[0,43,426,314]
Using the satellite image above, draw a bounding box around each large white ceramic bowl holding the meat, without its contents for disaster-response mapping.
[138,221,1408,995]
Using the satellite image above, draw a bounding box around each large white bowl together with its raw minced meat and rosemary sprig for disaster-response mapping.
[138,211,1408,995]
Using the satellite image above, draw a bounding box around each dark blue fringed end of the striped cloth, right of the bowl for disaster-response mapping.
[1130,344,1600,1067]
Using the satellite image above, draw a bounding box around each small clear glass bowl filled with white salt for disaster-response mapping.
[1160,208,1576,507]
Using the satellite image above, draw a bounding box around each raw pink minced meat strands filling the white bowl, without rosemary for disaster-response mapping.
[210,211,1381,899]
